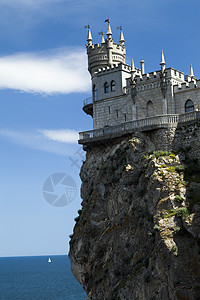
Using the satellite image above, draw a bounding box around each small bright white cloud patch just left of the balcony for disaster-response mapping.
[39,129,78,144]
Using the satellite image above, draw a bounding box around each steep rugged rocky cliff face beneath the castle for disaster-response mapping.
[69,123,200,300]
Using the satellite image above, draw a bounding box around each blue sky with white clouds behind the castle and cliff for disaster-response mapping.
[0,0,200,257]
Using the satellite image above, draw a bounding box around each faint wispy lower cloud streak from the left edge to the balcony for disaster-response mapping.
[0,129,78,156]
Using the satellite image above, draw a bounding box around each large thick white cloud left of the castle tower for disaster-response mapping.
[0,48,90,94]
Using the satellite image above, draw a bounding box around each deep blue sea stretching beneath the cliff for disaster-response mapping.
[0,255,86,300]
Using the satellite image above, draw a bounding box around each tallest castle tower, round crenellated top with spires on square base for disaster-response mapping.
[83,20,134,129]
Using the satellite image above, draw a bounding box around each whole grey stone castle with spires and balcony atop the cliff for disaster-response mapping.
[79,20,200,144]
